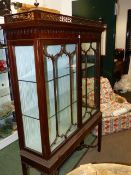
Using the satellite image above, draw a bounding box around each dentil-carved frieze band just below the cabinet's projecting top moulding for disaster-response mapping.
[6,27,101,41]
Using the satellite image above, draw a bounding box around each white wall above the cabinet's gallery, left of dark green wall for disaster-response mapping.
[12,0,72,15]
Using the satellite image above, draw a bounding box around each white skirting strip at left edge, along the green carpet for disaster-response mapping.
[0,131,18,150]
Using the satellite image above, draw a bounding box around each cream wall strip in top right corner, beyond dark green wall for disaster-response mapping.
[115,0,131,49]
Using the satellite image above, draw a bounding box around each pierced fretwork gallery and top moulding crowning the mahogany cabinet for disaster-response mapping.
[1,10,104,31]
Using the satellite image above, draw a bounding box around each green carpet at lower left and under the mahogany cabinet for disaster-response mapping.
[0,135,95,175]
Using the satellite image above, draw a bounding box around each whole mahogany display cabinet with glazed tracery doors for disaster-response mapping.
[2,10,104,174]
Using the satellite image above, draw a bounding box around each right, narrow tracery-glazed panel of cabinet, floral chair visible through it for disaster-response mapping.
[81,42,97,123]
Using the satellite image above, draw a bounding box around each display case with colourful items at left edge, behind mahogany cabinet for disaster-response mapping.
[0,27,18,149]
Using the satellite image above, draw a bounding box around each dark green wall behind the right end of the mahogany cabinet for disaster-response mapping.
[72,0,116,82]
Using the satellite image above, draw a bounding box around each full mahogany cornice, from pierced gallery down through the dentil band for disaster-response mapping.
[2,10,104,40]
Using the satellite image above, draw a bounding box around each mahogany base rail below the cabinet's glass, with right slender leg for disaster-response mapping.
[20,112,102,175]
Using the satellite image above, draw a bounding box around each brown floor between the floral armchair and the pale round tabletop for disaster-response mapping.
[78,129,131,166]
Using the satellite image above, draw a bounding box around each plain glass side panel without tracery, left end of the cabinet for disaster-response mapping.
[15,46,42,153]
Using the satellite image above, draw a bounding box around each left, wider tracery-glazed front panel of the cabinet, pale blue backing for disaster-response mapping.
[43,44,77,151]
